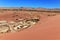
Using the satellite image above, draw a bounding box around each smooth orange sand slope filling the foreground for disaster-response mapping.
[0,15,60,40]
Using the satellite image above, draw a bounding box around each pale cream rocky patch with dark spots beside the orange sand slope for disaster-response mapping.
[0,18,39,33]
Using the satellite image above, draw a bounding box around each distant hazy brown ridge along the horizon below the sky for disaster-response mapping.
[0,7,60,11]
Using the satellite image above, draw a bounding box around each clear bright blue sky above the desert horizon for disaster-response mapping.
[0,0,60,8]
